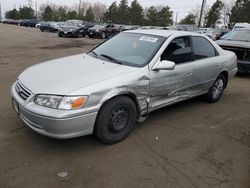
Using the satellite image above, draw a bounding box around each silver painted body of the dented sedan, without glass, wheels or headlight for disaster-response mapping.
[11,30,237,138]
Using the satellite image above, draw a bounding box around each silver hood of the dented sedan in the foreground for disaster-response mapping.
[18,54,138,95]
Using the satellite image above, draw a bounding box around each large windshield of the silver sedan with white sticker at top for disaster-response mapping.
[89,33,166,67]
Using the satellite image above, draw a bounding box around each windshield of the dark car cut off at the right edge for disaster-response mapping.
[221,30,250,42]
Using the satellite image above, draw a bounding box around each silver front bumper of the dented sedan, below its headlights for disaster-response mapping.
[11,84,97,139]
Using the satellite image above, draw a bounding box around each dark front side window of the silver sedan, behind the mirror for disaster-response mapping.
[161,37,192,64]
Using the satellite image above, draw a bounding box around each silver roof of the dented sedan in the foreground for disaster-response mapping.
[124,29,203,37]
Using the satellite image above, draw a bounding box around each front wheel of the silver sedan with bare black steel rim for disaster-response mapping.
[94,96,137,144]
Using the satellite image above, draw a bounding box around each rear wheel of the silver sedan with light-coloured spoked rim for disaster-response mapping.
[205,74,226,103]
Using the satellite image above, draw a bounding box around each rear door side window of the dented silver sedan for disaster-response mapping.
[193,37,217,60]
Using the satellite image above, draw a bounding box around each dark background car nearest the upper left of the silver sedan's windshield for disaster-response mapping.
[88,24,122,39]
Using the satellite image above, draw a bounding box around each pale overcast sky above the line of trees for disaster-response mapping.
[0,0,232,20]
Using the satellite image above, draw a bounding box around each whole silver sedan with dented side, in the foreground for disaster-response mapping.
[11,30,237,144]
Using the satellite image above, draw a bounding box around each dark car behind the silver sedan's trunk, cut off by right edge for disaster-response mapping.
[216,29,250,73]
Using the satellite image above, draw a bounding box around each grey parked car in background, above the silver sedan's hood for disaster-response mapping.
[58,20,94,37]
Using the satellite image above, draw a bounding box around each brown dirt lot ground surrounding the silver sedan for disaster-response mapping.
[0,24,250,188]
